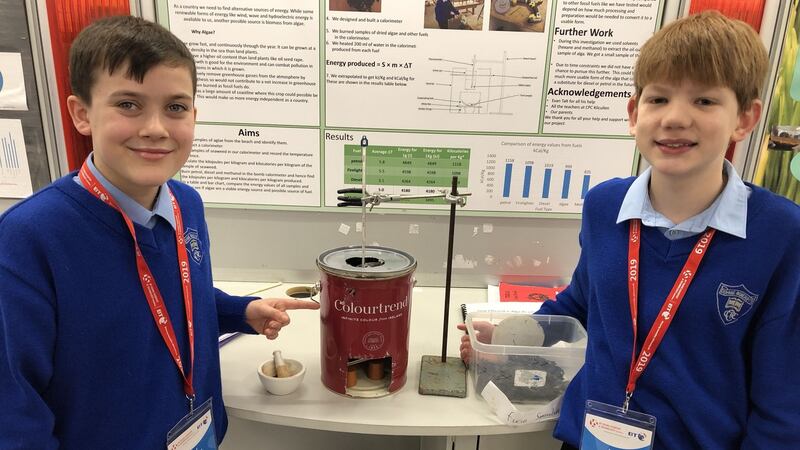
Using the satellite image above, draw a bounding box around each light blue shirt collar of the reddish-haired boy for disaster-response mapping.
[617,161,751,240]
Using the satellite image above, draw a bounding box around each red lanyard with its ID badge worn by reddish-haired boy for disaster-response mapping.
[580,219,716,450]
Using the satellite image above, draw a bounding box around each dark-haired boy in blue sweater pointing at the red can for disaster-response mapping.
[0,17,318,449]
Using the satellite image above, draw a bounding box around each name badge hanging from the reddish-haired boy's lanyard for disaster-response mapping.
[580,400,656,450]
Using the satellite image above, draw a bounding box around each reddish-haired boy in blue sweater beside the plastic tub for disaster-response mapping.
[462,12,800,450]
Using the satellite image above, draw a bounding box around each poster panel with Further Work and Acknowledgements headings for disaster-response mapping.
[542,0,661,135]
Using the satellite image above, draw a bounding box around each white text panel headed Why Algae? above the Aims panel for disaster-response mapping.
[168,0,320,126]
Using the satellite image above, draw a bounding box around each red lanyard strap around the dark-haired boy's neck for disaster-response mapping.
[78,162,194,410]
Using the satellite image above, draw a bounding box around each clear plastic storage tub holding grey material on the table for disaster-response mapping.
[466,311,586,404]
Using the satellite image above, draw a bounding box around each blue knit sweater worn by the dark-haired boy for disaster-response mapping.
[0,174,252,450]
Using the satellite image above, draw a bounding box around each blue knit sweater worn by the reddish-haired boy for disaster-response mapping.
[540,178,800,450]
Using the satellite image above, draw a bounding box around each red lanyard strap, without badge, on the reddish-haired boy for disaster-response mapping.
[622,219,716,412]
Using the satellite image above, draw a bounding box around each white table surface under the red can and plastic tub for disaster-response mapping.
[215,282,554,436]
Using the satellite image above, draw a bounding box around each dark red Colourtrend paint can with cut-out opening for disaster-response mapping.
[317,246,417,398]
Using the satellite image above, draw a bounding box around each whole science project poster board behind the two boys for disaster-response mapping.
[157,0,663,217]
